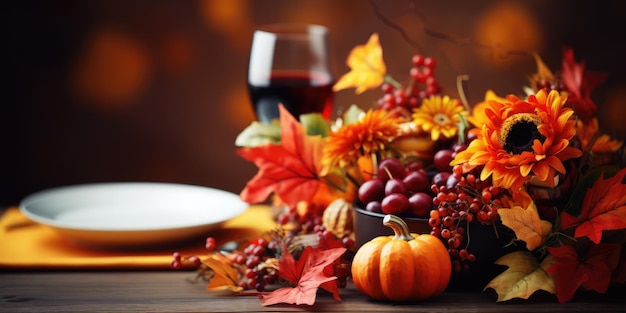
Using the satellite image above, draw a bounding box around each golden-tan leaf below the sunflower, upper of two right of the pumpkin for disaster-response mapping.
[498,197,552,251]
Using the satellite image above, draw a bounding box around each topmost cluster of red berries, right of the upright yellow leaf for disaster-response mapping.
[378,54,442,112]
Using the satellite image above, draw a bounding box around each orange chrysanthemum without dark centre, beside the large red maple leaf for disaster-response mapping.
[322,110,398,167]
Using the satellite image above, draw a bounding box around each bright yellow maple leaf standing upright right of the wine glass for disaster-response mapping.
[333,33,387,94]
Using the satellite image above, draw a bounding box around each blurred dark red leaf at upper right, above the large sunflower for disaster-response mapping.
[561,48,606,121]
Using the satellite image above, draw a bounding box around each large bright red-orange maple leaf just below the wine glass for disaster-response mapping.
[237,105,324,207]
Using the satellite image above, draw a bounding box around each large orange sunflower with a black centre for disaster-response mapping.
[451,90,582,192]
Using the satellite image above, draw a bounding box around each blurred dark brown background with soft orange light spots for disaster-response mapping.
[0,0,626,206]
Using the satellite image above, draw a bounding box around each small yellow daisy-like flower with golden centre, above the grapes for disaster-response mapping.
[413,96,467,141]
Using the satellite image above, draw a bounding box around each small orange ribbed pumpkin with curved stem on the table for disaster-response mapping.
[352,215,452,301]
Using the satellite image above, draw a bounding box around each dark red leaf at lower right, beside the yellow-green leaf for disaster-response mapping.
[547,243,621,303]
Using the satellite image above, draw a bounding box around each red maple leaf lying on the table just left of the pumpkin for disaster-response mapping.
[262,246,346,306]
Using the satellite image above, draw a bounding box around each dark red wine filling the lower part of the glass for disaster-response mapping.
[248,71,334,123]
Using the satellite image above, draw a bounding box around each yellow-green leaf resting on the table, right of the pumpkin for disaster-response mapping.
[484,251,556,302]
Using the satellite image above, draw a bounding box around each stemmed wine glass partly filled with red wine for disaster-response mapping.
[248,24,334,123]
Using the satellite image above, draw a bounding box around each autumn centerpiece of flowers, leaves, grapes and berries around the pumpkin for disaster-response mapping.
[173,34,626,305]
